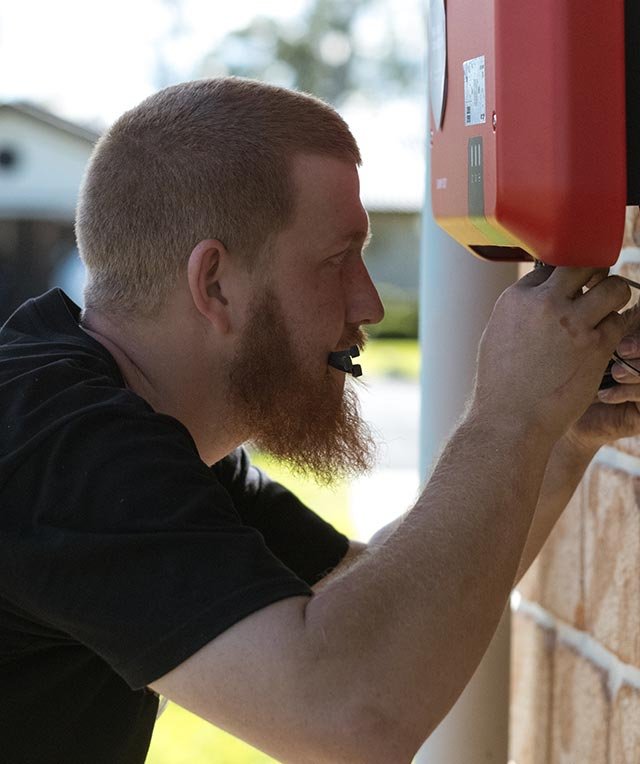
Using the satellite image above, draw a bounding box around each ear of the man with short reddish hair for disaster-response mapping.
[187,239,230,334]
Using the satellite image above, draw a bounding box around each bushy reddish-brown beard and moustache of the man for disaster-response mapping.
[229,290,376,484]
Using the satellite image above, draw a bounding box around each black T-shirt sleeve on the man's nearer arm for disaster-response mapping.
[0,405,311,689]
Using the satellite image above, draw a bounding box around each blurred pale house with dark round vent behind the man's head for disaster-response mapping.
[0,103,98,314]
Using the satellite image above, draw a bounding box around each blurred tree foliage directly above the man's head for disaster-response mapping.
[201,0,421,105]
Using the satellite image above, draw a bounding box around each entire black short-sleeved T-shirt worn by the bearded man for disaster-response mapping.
[0,289,348,764]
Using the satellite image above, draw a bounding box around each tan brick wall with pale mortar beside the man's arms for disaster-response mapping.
[510,208,640,764]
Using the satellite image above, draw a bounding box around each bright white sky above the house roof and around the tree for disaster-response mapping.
[0,0,422,126]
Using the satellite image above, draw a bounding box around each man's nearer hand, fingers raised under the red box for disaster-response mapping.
[472,268,640,441]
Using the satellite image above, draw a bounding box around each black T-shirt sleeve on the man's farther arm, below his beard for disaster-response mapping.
[212,448,349,585]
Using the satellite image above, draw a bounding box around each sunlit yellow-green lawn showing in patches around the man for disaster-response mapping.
[147,339,420,764]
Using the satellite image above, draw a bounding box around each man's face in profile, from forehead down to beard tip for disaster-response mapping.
[230,156,383,481]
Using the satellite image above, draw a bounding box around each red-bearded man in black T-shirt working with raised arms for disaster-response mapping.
[0,79,640,764]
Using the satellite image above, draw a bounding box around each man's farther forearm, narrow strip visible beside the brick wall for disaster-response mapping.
[515,436,597,583]
